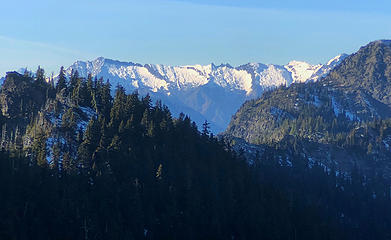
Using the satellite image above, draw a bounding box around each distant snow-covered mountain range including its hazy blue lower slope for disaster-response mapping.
[67,54,347,133]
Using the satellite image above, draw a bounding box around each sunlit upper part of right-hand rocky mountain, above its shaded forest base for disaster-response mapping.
[226,41,391,144]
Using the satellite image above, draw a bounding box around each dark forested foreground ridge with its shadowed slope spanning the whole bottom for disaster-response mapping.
[0,62,391,240]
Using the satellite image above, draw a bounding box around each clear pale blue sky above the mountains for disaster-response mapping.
[0,0,391,76]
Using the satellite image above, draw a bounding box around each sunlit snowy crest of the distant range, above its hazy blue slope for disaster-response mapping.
[67,55,346,96]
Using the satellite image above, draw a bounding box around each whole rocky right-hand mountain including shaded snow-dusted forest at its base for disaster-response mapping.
[226,41,391,176]
